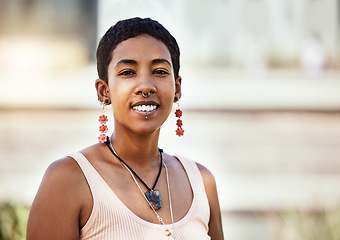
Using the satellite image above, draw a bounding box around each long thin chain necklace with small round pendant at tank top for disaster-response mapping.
[106,138,176,239]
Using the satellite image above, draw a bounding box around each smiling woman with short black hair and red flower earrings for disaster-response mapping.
[27,18,223,240]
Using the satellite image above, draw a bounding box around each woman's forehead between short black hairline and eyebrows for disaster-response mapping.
[110,35,171,64]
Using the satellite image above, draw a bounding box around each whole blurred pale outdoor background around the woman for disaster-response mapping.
[0,0,340,240]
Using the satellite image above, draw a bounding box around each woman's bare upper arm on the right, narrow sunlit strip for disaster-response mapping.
[197,163,224,240]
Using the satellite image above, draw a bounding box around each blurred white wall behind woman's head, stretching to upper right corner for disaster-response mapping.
[98,0,340,64]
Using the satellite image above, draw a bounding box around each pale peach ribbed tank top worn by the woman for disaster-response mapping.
[69,152,210,240]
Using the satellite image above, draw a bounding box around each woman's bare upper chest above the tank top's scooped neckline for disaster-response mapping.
[84,158,194,224]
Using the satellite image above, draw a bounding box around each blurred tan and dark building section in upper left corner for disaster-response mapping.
[0,0,97,70]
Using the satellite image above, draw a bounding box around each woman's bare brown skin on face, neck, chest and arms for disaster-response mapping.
[27,36,223,240]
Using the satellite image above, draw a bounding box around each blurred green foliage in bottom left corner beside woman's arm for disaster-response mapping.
[0,202,29,240]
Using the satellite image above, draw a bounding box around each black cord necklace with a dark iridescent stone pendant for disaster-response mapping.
[105,137,163,210]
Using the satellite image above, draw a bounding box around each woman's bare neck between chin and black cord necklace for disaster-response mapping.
[110,126,159,167]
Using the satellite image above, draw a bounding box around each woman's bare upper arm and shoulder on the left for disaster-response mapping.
[27,158,85,240]
